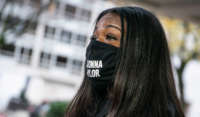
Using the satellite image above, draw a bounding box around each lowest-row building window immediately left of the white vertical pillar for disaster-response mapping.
[19,47,32,64]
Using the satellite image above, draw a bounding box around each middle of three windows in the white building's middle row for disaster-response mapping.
[60,30,72,43]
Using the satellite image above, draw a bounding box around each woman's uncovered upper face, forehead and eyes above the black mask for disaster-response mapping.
[93,13,121,47]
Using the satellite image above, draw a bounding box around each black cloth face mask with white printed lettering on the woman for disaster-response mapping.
[85,39,119,93]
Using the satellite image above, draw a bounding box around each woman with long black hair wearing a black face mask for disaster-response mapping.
[66,7,184,117]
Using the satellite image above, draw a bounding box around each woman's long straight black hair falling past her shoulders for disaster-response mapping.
[66,7,184,117]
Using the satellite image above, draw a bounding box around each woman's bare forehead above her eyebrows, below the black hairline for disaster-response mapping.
[97,13,121,27]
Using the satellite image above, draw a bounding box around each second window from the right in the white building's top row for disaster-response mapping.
[65,4,76,18]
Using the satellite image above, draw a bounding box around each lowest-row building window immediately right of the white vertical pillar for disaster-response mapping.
[40,52,51,68]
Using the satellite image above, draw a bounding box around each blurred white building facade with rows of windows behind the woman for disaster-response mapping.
[0,0,113,107]
